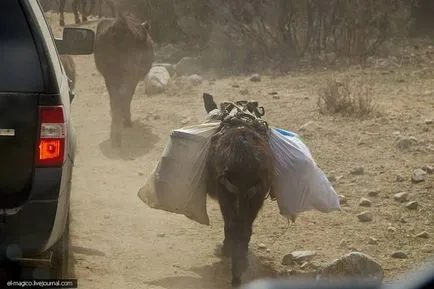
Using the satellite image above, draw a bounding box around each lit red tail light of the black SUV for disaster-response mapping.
[36,105,66,167]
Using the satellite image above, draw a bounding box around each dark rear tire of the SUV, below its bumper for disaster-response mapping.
[50,214,70,279]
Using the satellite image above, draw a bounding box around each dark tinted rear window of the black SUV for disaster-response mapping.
[0,0,44,93]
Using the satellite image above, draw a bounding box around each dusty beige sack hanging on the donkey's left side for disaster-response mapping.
[138,122,220,225]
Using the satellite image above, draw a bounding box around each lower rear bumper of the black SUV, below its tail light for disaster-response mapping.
[0,159,72,258]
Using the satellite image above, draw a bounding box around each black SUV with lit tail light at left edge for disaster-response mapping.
[0,0,95,278]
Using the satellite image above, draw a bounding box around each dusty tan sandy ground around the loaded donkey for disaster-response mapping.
[45,11,434,289]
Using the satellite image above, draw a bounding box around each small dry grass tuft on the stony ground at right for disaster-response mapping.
[318,79,376,117]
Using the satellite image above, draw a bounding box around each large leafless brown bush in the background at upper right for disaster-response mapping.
[198,0,409,71]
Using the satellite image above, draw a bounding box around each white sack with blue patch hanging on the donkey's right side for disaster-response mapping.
[269,128,340,221]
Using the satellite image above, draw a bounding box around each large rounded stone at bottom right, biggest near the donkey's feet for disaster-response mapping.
[318,252,384,281]
